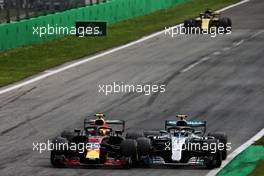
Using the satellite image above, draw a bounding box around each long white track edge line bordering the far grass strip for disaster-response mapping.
[0,0,250,95]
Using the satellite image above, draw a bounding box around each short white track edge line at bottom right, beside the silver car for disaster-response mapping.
[206,128,264,176]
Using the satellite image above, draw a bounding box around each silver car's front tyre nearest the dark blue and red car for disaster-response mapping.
[137,137,151,157]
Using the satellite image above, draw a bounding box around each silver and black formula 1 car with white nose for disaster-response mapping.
[127,115,230,168]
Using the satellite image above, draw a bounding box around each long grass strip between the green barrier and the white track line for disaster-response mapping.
[0,0,240,87]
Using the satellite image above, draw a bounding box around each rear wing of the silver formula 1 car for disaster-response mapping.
[165,120,206,134]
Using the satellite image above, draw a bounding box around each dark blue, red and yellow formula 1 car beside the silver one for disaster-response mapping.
[50,114,137,168]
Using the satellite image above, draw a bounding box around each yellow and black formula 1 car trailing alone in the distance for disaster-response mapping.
[184,9,232,33]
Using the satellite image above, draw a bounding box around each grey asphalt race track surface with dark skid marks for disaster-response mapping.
[0,0,264,176]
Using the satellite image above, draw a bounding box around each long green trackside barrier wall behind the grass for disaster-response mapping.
[0,0,187,51]
